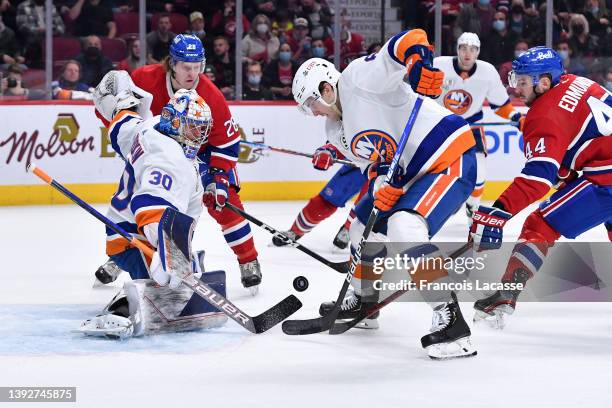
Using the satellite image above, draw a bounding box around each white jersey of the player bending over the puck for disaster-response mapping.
[326,30,474,185]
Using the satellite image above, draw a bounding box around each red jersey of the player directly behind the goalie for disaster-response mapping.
[131,64,240,172]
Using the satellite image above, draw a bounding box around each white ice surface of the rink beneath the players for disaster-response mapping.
[0,202,612,408]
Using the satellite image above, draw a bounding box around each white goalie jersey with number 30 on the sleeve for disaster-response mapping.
[106,111,204,256]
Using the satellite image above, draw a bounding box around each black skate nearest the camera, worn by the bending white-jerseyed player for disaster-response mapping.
[421,292,477,360]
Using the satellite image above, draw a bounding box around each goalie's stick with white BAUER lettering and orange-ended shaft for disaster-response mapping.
[28,163,302,333]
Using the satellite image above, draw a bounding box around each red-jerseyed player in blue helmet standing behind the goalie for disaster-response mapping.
[96,34,262,294]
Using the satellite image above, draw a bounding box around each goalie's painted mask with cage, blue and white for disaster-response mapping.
[156,89,212,159]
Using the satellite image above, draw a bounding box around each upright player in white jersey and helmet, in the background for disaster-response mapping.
[433,32,522,222]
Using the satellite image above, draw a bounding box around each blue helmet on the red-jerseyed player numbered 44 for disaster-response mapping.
[508,47,564,88]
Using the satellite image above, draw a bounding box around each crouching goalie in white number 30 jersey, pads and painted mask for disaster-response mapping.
[80,71,227,338]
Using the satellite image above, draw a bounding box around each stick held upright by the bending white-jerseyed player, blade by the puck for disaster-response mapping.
[283,95,423,335]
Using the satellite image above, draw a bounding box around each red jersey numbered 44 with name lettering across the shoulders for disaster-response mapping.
[498,75,612,214]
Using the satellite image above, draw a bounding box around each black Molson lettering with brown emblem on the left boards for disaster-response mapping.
[0,113,94,168]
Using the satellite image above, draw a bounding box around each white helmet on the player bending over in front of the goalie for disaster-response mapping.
[291,58,340,116]
